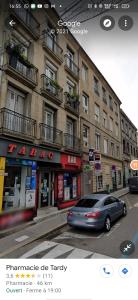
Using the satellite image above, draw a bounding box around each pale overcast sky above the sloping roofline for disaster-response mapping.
[52,0,138,128]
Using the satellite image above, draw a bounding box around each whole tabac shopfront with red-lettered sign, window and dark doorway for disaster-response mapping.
[0,139,60,229]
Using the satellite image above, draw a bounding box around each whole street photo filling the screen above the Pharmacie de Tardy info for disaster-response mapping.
[0,0,138,259]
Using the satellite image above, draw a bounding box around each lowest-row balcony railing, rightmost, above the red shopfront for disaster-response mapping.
[64,133,80,152]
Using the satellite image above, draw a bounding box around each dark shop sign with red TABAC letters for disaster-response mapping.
[0,140,60,163]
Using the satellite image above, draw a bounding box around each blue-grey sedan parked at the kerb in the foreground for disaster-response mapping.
[67,194,127,231]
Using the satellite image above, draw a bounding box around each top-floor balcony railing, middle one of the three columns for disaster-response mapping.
[43,31,63,60]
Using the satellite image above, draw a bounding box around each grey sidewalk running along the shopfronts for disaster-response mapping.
[0,188,128,258]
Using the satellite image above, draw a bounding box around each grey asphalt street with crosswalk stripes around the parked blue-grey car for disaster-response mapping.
[2,194,138,258]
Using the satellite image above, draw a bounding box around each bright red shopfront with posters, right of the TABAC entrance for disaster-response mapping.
[55,154,81,209]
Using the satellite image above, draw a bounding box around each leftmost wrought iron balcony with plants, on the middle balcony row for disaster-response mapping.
[5,46,38,88]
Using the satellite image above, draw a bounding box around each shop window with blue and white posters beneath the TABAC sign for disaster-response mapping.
[3,160,36,211]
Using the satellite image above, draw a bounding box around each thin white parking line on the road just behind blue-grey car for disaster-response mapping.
[53,231,104,240]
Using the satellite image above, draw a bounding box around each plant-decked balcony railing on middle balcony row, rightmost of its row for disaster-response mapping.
[65,92,80,115]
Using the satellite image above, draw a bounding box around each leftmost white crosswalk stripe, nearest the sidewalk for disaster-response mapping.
[20,241,57,258]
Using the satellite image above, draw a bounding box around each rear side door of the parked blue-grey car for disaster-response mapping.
[104,196,116,221]
